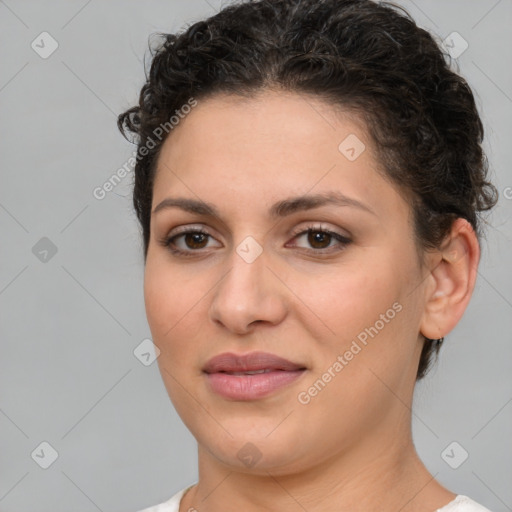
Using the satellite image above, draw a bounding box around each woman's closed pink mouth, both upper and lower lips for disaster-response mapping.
[203,352,307,401]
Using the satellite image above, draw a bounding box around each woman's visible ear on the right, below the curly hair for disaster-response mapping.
[420,218,480,339]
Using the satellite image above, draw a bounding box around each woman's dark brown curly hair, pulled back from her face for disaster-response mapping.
[118,0,498,379]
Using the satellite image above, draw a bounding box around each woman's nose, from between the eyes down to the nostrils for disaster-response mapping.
[210,245,287,334]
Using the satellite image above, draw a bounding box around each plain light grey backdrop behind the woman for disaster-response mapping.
[0,0,512,512]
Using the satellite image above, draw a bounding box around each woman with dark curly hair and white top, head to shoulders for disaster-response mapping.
[119,0,496,512]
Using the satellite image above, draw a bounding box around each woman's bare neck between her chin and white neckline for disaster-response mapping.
[180,423,455,512]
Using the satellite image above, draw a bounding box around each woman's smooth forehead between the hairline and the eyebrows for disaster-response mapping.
[153,91,403,222]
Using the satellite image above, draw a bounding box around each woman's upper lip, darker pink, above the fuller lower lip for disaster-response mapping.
[203,352,305,375]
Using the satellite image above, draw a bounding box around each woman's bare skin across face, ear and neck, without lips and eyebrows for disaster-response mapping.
[144,90,479,512]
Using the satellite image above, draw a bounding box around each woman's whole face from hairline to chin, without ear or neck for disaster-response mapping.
[144,91,424,474]
